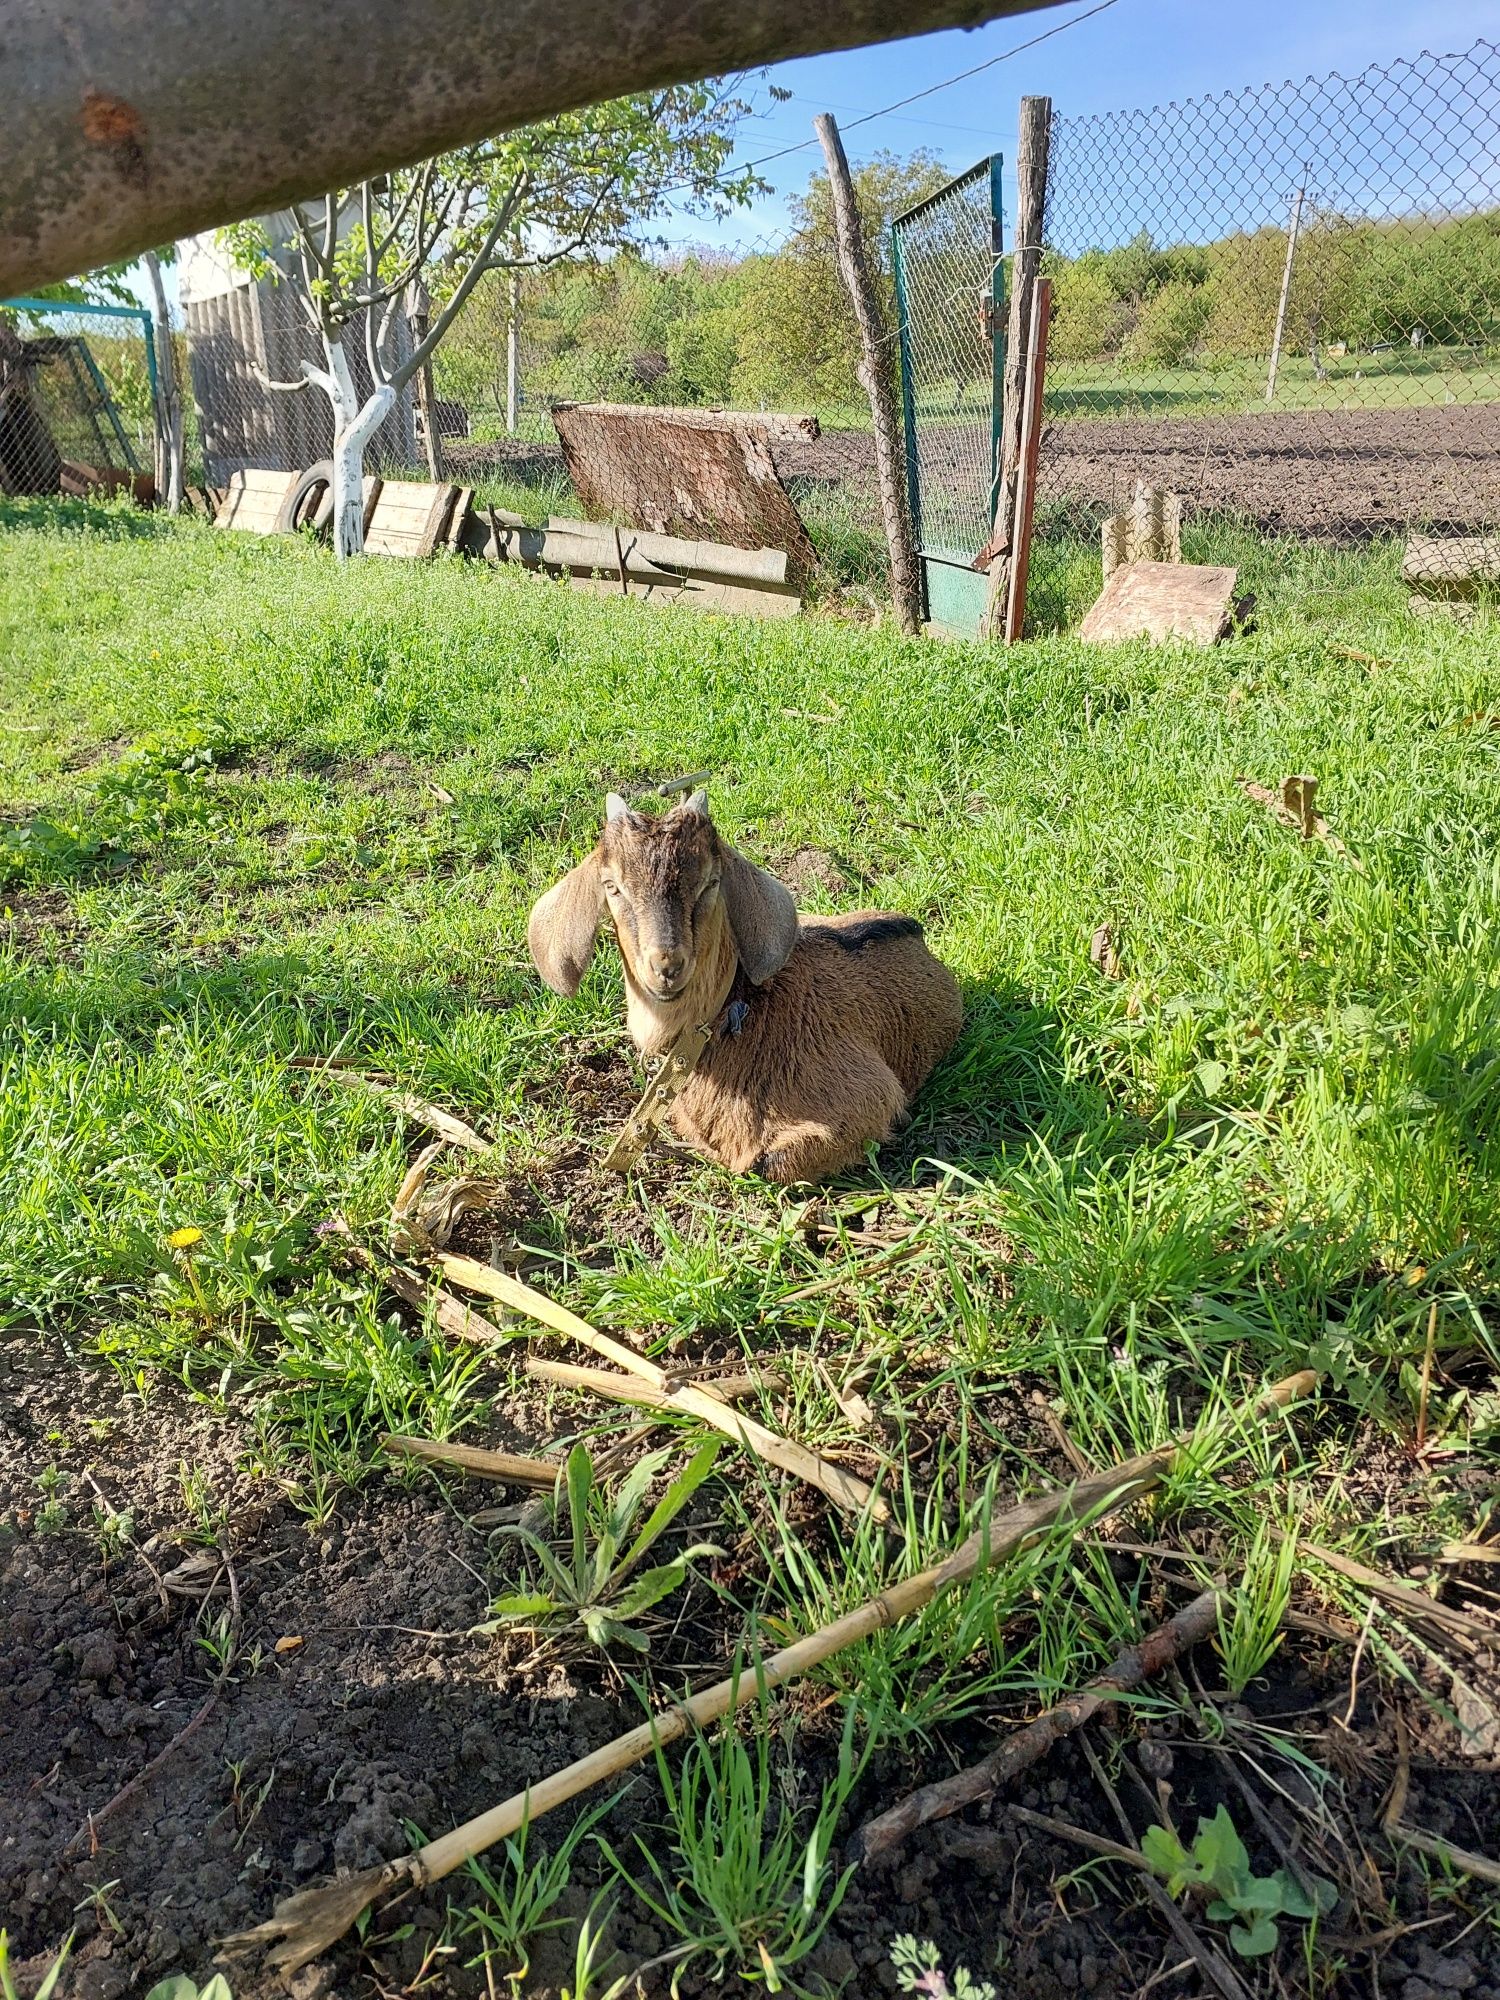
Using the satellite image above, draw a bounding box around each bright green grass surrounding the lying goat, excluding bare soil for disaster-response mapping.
[0,502,1500,1950]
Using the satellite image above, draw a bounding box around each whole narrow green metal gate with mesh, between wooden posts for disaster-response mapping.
[892,154,1006,638]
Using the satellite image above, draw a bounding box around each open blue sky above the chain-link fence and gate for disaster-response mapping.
[662,0,1500,244]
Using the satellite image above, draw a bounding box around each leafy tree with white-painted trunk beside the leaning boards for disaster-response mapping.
[226,82,760,558]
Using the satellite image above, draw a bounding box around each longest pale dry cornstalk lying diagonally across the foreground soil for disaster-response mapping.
[224,1370,1318,1972]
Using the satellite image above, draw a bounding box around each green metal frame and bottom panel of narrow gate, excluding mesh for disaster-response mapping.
[890,152,1006,638]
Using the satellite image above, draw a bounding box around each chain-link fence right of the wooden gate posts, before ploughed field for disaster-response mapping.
[1038,42,1500,610]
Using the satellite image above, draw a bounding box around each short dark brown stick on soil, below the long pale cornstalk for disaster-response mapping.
[850,1582,1222,1862]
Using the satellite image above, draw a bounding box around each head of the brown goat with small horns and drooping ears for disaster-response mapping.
[526,792,796,1006]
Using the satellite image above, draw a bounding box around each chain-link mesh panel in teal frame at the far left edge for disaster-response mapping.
[0,300,156,494]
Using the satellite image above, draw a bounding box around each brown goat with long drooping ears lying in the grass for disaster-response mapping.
[526,792,964,1182]
